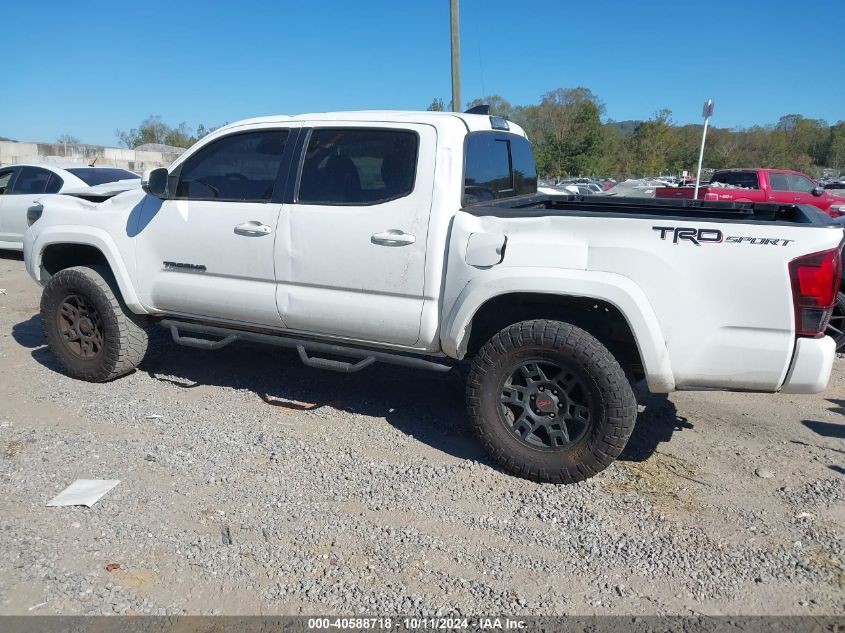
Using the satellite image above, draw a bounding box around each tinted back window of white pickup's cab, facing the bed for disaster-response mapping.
[463,132,537,205]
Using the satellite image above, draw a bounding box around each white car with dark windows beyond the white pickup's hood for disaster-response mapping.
[0,164,140,251]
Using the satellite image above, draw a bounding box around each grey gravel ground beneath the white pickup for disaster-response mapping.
[0,254,845,615]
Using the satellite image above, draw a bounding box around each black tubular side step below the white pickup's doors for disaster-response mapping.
[159,319,452,374]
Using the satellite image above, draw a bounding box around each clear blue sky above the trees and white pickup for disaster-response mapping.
[0,0,845,145]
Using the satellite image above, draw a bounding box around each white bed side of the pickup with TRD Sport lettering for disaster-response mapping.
[445,195,843,391]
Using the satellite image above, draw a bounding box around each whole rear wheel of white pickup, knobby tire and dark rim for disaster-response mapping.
[467,320,637,483]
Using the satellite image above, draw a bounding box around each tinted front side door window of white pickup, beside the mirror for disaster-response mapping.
[175,130,288,202]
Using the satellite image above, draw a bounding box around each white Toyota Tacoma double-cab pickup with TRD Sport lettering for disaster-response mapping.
[19,112,843,483]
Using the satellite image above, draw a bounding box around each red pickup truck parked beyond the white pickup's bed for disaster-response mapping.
[654,169,845,218]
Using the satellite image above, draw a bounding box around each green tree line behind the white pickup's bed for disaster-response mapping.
[428,87,845,179]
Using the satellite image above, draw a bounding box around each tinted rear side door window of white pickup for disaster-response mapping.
[297,128,419,205]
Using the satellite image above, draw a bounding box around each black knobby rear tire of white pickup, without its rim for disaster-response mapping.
[466,320,637,484]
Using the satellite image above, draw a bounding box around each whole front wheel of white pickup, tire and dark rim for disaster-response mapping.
[41,266,148,382]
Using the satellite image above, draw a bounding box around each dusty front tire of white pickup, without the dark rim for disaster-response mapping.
[41,266,149,382]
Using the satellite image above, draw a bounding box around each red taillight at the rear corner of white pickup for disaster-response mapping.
[789,248,842,336]
